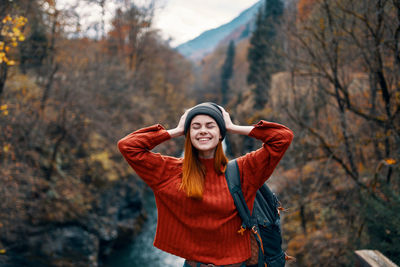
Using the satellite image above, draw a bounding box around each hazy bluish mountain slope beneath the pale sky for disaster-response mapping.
[176,1,263,61]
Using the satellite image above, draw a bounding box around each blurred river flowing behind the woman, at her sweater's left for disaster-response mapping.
[103,190,184,267]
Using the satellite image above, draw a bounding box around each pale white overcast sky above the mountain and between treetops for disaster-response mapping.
[57,0,259,47]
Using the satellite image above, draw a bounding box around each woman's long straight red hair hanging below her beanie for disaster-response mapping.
[180,131,228,199]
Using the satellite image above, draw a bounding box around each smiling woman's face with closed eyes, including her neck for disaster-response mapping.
[190,115,221,158]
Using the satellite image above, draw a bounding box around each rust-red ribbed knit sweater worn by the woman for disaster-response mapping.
[118,121,293,265]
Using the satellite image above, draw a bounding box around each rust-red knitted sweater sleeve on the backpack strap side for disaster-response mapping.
[238,121,293,195]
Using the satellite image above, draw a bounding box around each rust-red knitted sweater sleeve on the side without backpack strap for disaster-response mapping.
[118,124,179,191]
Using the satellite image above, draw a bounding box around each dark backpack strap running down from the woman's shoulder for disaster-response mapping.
[225,159,266,267]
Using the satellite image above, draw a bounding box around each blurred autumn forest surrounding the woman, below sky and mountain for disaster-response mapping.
[0,0,400,266]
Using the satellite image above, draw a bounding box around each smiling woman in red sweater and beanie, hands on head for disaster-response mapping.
[118,102,293,267]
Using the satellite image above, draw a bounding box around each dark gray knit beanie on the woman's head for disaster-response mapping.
[184,102,226,139]
